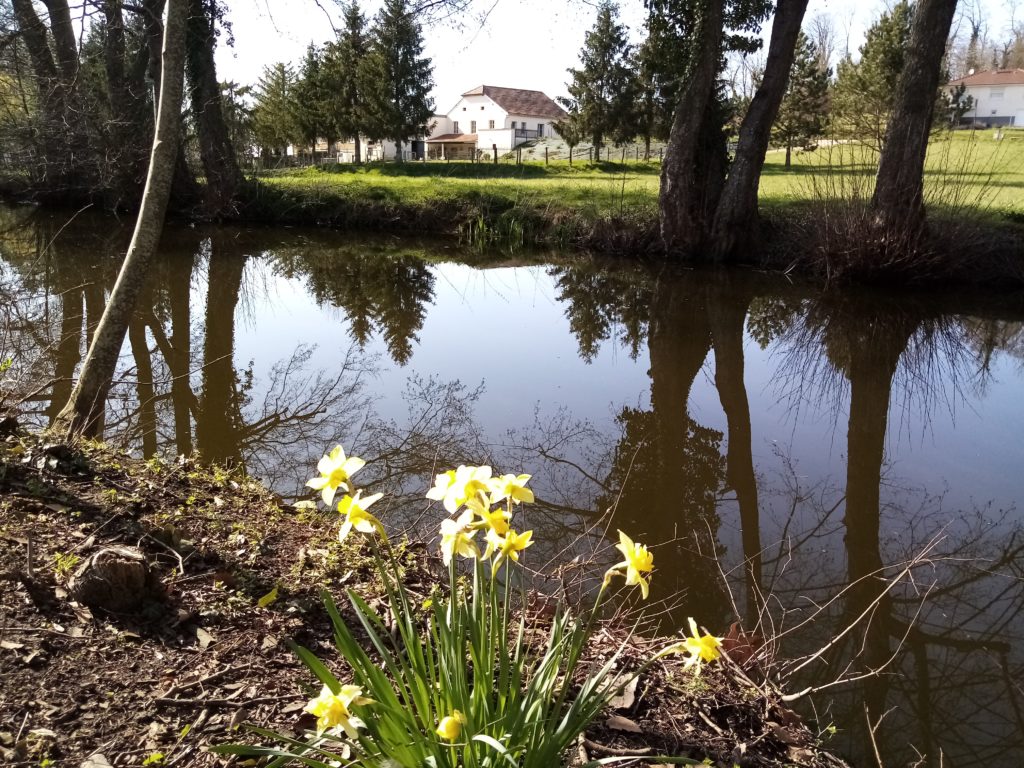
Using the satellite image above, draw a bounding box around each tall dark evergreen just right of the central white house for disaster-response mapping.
[562,0,637,150]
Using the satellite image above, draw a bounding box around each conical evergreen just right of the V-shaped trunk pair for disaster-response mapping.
[772,33,831,168]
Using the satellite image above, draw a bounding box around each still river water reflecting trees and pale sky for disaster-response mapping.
[0,209,1024,766]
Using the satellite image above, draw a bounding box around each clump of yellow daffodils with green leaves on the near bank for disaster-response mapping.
[240,445,722,768]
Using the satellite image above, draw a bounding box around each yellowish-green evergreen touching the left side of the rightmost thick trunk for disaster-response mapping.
[833,0,913,152]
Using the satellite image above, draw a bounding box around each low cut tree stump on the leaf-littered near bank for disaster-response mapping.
[69,546,161,613]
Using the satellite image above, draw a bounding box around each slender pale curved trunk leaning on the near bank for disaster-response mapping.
[58,0,187,436]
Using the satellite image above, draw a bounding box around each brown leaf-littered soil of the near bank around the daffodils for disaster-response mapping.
[0,428,843,766]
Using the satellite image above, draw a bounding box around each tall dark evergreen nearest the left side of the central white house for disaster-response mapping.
[358,0,434,158]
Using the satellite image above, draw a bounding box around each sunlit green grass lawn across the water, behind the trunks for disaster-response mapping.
[260,130,1024,224]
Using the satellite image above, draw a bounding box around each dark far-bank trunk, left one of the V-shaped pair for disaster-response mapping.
[658,0,724,255]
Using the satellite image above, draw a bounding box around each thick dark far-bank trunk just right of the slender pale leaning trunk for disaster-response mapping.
[186,0,243,218]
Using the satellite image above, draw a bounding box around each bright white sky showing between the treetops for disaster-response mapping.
[217,0,1024,112]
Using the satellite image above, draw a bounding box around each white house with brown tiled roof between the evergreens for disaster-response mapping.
[426,85,566,160]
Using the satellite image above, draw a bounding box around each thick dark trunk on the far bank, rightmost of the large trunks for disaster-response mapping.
[871,0,956,246]
